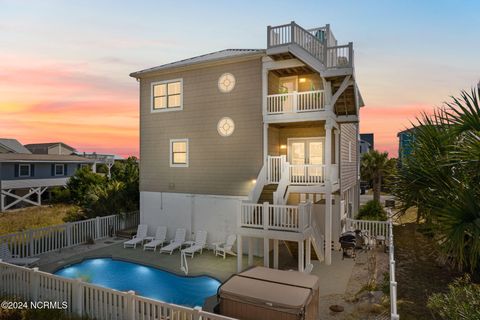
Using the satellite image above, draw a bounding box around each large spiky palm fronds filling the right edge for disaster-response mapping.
[394,88,480,271]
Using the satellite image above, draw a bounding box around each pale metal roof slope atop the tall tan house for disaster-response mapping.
[130,49,265,78]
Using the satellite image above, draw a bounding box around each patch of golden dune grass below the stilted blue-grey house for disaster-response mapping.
[0,204,73,236]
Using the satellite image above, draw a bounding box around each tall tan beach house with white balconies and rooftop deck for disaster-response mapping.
[131,22,363,271]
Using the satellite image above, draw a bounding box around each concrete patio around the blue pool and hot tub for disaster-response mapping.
[38,238,355,296]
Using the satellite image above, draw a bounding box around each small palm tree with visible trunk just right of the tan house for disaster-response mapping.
[360,150,394,202]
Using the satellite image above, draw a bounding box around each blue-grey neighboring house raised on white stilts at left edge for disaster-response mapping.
[0,148,92,211]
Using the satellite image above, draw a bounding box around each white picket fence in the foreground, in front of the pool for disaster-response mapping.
[0,261,234,320]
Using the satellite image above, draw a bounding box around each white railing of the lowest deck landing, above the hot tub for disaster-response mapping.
[239,202,312,232]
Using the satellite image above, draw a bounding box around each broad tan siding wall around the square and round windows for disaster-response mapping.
[140,57,263,196]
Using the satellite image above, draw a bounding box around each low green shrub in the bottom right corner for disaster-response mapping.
[427,275,480,320]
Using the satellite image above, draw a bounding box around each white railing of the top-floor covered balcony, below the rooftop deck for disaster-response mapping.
[267,90,325,115]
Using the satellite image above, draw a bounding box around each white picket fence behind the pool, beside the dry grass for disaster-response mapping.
[0,212,140,258]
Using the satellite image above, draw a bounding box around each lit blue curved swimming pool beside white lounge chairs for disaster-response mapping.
[55,258,220,307]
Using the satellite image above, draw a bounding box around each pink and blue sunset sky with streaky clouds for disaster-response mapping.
[0,0,480,156]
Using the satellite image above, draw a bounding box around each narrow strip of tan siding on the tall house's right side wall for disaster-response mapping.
[340,123,358,192]
